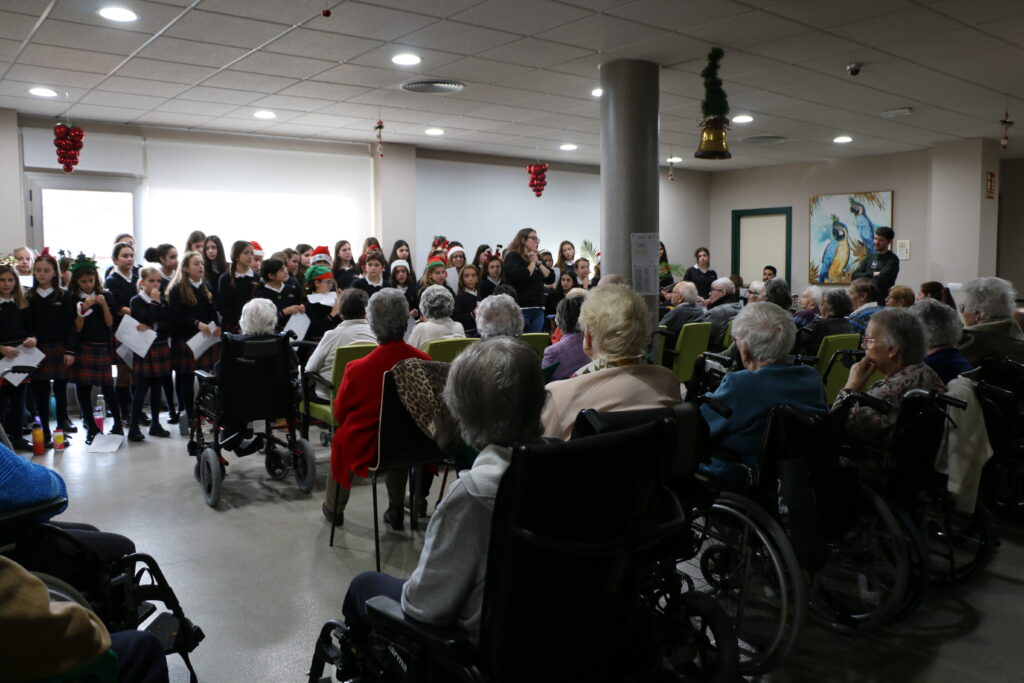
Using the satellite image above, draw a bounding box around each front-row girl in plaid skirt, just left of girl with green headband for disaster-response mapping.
[26,250,78,449]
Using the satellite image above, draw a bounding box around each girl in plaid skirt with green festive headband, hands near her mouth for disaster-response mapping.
[68,254,125,443]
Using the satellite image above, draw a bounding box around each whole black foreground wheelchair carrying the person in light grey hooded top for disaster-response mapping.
[309,419,737,683]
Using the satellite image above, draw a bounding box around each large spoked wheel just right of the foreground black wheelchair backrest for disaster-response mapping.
[677,493,804,680]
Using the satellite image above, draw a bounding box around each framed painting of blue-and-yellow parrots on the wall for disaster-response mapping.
[807,189,893,285]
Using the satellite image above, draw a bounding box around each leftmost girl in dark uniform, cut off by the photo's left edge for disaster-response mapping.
[0,263,36,451]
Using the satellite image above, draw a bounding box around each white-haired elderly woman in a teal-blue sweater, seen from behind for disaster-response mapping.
[700,301,826,479]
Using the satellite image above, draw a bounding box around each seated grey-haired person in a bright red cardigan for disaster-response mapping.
[323,288,428,529]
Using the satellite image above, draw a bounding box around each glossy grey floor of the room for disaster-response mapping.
[34,419,1024,683]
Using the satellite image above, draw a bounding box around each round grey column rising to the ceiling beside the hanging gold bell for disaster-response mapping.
[600,59,660,314]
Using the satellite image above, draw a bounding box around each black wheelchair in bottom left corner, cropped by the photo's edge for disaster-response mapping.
[0,498,205,683]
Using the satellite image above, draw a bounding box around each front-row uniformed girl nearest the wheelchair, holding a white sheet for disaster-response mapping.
[167,252,220,436]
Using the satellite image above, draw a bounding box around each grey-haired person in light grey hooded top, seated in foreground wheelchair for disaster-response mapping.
[338,335,544,680]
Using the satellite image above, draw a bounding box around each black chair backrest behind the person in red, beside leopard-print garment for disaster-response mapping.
[370,371,445,472]
